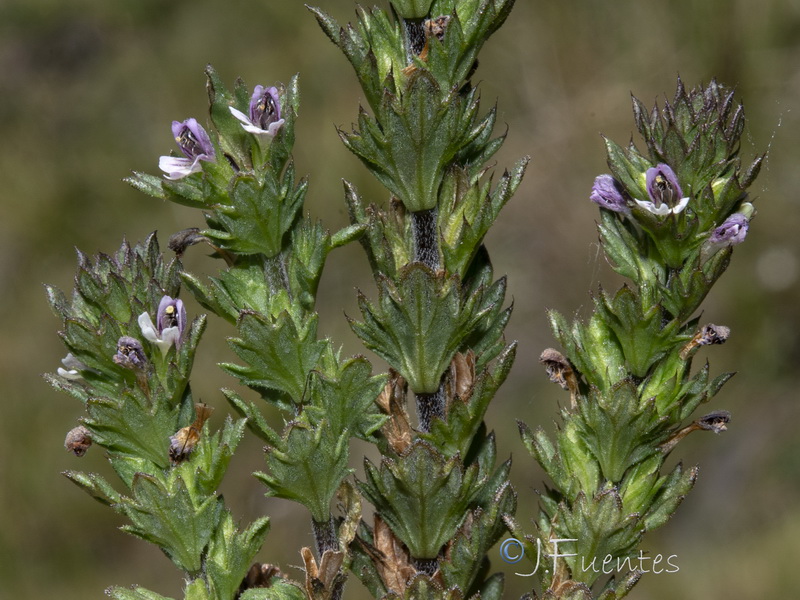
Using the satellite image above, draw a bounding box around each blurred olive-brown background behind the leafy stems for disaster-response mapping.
[0,0,800,600]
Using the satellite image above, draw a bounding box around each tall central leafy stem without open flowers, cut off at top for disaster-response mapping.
[312,0,527,600]
